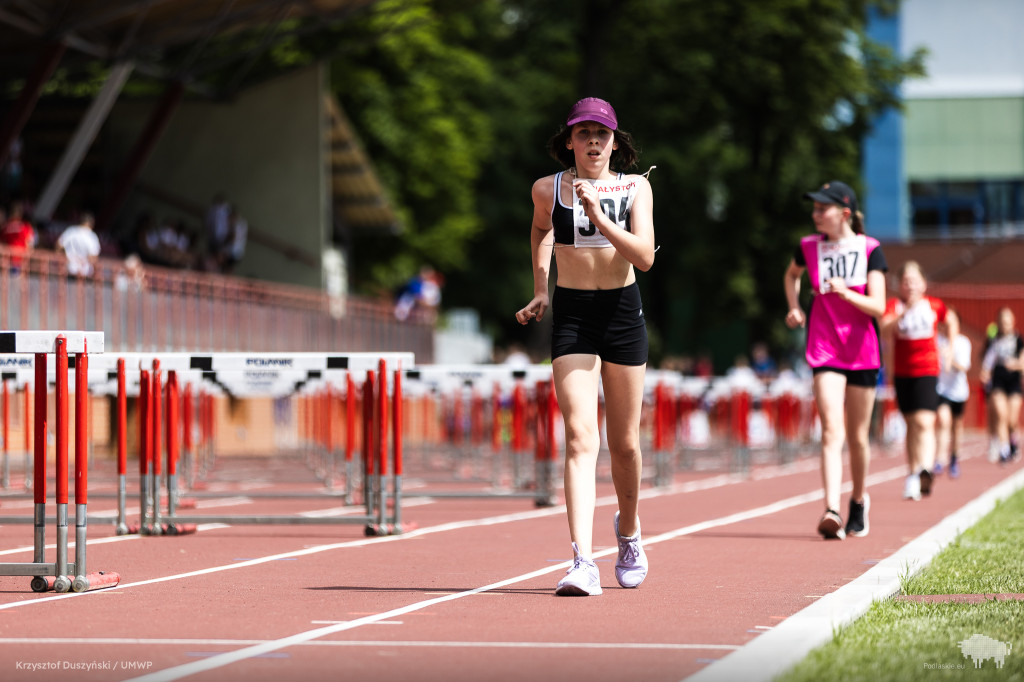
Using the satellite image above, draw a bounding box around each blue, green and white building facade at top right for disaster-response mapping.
[862,0,1024,241]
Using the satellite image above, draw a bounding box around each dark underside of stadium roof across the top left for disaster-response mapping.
[0,0,376,97]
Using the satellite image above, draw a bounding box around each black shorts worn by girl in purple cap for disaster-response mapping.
[551,282,647,367]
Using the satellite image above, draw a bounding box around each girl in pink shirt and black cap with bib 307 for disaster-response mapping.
[783,181,888,540]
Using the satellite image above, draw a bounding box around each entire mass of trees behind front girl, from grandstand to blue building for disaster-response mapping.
[334,0,922,368]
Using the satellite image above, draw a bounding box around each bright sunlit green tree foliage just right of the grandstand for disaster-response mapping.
[332,0,493,289]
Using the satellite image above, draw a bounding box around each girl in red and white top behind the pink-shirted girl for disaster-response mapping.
[882,260,946,500]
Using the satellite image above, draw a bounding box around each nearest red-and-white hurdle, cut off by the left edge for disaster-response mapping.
[0,331,121,593]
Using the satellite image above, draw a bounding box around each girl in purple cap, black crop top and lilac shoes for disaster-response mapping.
[516,97,654,596]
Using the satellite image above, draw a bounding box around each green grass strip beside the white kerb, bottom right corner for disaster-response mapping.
[776,491,1024,682]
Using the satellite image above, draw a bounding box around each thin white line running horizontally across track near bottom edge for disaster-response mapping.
[0,624,739,651]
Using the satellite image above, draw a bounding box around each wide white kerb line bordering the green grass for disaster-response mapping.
[686,470,1024,682]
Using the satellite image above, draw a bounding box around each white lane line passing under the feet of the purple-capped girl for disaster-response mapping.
[121,466,905,682]
